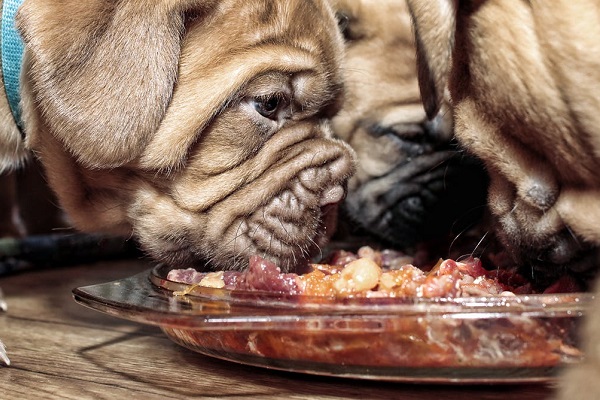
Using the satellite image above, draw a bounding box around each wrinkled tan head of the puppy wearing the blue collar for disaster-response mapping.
[19,0,354,270]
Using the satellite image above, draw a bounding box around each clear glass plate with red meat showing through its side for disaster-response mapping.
[73,266,593,383]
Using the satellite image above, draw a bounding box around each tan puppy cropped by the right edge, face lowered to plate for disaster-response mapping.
[408,0,600,399]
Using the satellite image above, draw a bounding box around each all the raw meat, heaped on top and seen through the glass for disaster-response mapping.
[163,247,582,373]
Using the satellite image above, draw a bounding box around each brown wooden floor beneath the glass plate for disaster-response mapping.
[0,261,552,400]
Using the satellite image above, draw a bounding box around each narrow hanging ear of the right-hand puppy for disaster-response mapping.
[408,0,458,119]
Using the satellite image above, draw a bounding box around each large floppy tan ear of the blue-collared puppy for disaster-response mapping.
[17,0,214,168]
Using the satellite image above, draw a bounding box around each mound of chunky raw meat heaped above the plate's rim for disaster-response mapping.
[167,246,577,298]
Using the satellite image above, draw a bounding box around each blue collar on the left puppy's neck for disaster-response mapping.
[1,0,23,129]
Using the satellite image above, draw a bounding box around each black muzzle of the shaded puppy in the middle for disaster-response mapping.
[345,151,487,248]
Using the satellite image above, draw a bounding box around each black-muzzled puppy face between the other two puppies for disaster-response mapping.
[333,0,486,246]
